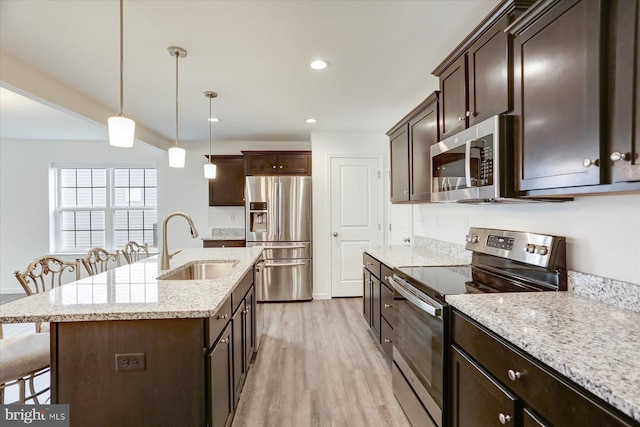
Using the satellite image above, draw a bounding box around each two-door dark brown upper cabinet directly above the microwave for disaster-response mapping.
[433,0,533,139]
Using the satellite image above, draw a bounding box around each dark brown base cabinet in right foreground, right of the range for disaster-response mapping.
[450,310,637,427]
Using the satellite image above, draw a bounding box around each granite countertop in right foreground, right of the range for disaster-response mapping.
[446,292,640,421]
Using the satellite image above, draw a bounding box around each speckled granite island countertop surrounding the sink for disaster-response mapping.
[0,247,262,323]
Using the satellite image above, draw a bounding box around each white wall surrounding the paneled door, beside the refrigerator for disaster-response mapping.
[311,132,389,299]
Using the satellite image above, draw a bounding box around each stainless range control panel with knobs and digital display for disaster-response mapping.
[465,227,566,267]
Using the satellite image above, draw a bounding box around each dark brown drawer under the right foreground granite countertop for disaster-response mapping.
[451,311,631,427]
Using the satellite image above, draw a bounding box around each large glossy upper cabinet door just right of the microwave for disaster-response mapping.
[514,0,608,190]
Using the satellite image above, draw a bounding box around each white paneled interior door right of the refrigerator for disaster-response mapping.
[330,157,382,297]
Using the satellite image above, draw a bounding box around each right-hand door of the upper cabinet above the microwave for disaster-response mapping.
[467,16,513,126]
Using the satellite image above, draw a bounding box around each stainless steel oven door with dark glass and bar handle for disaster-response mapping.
[389,275,444,426]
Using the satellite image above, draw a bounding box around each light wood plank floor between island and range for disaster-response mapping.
[233,298,410,427]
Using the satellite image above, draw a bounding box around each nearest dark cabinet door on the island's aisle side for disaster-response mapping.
[207,325,233,427]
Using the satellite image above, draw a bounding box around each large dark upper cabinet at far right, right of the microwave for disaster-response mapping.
[508,0,640,195]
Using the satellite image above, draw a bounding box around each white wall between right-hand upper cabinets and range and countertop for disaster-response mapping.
[413,194,640,284]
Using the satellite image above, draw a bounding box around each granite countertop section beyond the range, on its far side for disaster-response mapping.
[365,245,471,267]
